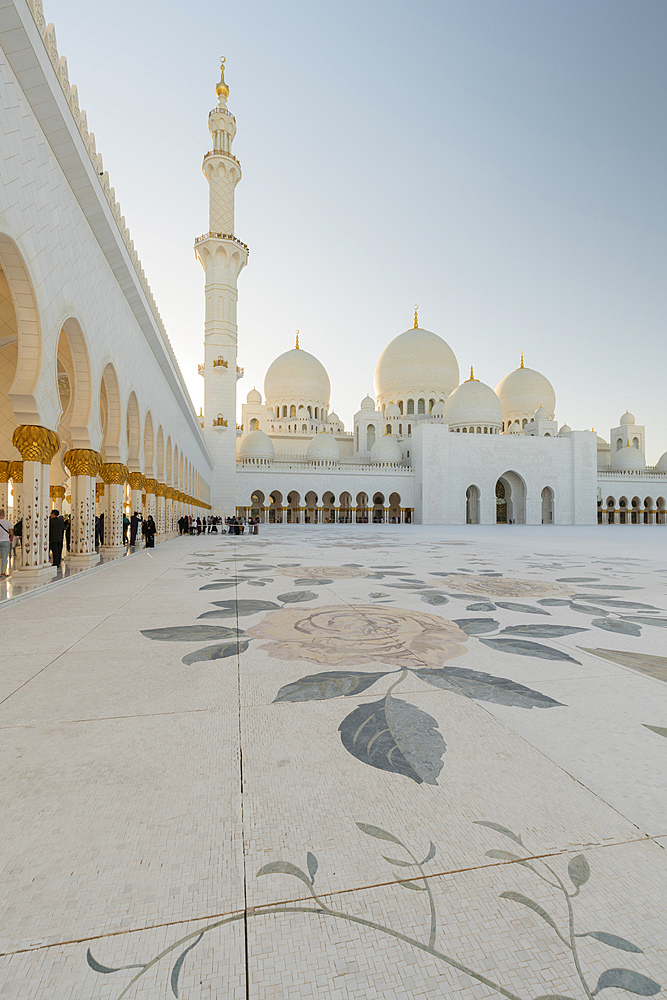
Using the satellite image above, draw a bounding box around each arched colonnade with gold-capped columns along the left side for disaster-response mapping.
[0,233,210,577]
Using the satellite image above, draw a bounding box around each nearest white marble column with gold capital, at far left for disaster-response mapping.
[12,424,60,580]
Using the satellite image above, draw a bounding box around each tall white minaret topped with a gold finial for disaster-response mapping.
[195,58,248,517]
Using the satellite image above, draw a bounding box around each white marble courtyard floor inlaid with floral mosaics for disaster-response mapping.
[0,525,667,1000]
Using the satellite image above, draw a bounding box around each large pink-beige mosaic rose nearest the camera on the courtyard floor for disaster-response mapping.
[247,604,468,667]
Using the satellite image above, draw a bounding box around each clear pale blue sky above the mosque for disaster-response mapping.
[49,0,667,462]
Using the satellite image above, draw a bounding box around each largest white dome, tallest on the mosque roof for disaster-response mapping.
[375,327,459,405]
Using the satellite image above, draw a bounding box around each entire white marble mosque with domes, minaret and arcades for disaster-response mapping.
[0,0,667,579]
